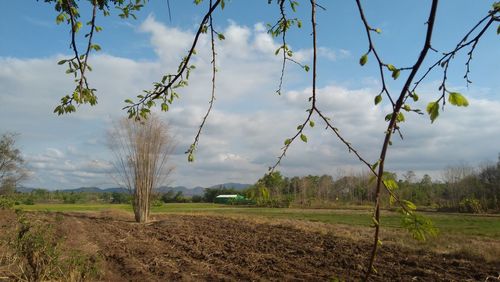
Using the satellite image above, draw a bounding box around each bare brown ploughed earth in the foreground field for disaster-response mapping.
[0,211,500,281]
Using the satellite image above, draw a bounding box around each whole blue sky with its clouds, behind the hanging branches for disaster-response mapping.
[0,0,500,190]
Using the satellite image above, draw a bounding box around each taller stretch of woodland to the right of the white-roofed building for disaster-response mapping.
[240,155,500,213]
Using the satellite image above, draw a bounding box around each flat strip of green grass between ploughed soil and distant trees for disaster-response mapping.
[18,203,500,238]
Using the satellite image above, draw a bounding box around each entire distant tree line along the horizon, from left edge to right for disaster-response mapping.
[0,154,500,213]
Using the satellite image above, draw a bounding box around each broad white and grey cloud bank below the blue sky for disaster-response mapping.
[0,16,500,188]
